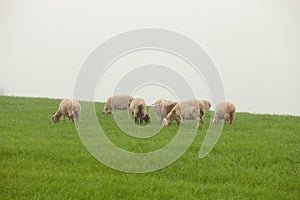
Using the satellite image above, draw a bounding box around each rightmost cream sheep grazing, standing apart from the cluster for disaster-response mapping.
[213,102,236,125]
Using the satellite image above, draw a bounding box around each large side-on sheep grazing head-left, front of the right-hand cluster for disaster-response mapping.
[162,100,205,129]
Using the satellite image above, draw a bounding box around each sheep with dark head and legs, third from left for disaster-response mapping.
[129,98,151,124]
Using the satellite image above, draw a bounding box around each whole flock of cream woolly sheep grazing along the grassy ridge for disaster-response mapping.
[52,95,236,129]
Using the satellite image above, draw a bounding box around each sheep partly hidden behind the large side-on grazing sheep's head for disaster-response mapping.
[153,99,176,122]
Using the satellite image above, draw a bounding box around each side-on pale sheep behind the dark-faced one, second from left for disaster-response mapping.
[102,95,134,115]
